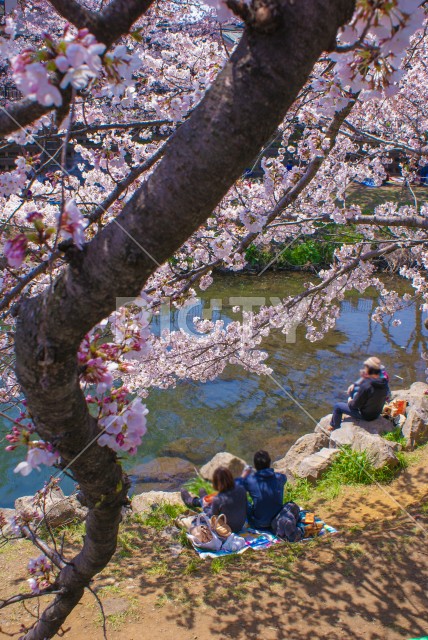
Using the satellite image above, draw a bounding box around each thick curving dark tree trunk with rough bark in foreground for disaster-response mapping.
[12,0,354,640]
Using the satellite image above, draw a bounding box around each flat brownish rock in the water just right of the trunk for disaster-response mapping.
[130,457,196,490]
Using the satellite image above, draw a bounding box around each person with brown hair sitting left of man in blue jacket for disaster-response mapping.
[181,467,247,533]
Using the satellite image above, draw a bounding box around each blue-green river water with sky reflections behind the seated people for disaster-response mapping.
[0,272,428,507]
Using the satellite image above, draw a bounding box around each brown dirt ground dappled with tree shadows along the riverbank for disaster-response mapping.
[0,447,428,640]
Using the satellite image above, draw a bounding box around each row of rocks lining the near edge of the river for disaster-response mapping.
[4,382,428,527]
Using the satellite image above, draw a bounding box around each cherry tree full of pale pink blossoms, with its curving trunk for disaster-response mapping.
[0,0,428,640]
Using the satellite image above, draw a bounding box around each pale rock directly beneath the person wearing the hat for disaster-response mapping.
[330,422,398,469]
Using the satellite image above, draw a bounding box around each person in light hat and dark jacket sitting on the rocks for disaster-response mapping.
[330,357,389,430]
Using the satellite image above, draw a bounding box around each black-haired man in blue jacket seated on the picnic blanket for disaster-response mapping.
[235,451,287,529]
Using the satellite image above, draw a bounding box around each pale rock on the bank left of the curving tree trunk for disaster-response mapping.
[15,489,87,527]
